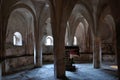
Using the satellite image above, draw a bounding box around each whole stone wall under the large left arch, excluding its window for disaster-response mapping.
[4,8,34,73]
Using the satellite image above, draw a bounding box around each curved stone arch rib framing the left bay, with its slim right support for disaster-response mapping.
[6,0,37,63]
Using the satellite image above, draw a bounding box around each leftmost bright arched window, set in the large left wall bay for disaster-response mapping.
[13,32,22,46]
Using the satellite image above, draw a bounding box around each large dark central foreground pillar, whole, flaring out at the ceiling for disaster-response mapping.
[49,0,77,80]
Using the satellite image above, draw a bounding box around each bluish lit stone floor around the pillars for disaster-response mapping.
[2,64,118,80]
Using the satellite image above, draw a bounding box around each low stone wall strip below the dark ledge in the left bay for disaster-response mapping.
[5,56,34,73]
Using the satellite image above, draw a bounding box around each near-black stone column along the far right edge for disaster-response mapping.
[109,0,120,80]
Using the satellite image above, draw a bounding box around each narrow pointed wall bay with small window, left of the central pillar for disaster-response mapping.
[42,17,54,63]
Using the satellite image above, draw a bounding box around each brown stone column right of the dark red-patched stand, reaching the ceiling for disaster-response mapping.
[93,1,101,68]
